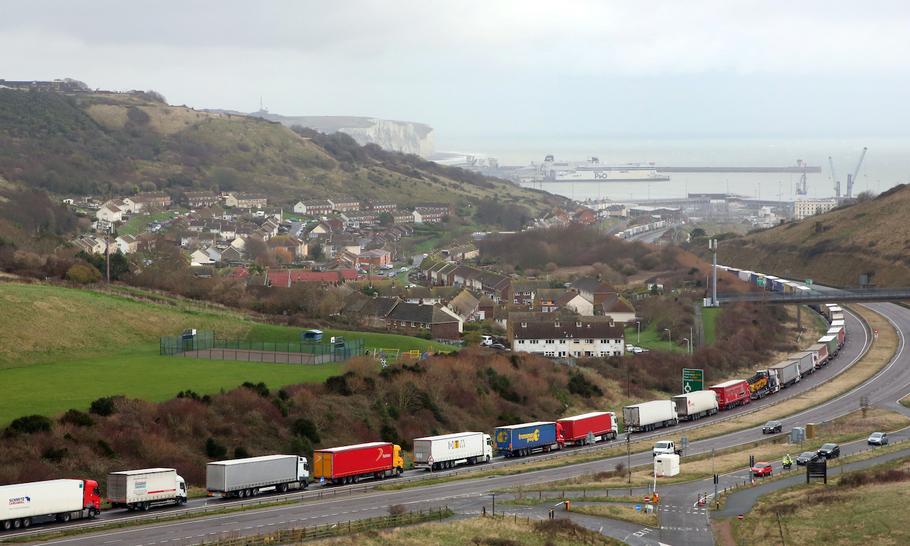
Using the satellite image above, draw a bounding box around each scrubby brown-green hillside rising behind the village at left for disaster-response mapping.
[0,90,555,213]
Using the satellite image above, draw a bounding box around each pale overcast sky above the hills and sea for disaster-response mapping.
[0,0,910,140]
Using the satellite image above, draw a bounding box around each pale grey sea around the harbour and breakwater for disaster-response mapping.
[436,134,910,202]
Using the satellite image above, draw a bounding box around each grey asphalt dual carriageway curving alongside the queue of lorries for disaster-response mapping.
[3,303,910,546]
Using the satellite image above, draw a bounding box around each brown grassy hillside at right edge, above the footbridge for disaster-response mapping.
[692,185,910,287]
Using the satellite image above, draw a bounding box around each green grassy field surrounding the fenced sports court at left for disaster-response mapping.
[0,283,452,426]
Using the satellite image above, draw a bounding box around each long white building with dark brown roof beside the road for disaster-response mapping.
[509,317,625,357]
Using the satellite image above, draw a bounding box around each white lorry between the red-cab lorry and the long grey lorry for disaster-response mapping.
[107,468,186,511]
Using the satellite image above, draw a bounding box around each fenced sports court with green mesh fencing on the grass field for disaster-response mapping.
[159,330,364,364]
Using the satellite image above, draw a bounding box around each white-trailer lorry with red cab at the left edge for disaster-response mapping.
[0,480,101,531]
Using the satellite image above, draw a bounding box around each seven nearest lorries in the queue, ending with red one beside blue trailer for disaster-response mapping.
[0,412,617,530]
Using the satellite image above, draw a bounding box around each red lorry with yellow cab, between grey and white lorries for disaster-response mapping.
[313,442,404,484]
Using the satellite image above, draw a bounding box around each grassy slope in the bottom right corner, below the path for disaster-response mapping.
[713,459,910,546]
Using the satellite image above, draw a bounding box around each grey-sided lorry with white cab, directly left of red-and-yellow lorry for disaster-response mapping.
[205,455,310,498]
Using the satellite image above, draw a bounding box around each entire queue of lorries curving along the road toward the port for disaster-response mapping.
[0,266,845,530]
